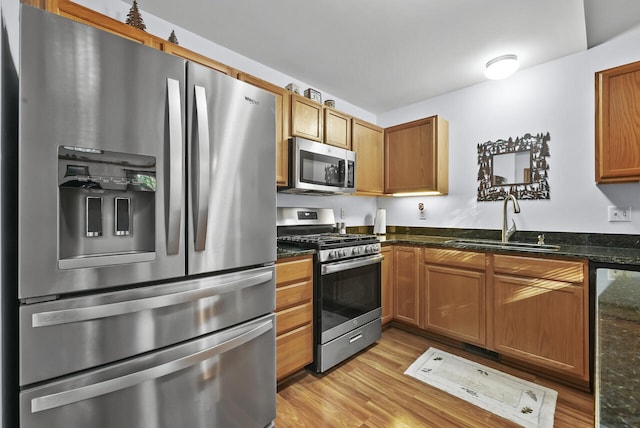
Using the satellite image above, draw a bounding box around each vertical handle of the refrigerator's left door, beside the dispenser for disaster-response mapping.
[165,78,183,254]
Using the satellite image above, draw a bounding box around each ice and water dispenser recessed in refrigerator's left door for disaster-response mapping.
[58,146,156,269]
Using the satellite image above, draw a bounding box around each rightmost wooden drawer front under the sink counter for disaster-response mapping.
[493,254,586,283]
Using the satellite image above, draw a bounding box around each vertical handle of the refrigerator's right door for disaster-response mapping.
[192,85,211,251]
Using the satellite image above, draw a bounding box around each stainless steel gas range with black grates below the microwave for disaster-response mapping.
[277,207,384,373]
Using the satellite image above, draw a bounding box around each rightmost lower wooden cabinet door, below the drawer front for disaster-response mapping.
[494,275,589,380]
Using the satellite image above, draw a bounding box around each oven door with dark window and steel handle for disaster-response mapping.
[316,254,384,344]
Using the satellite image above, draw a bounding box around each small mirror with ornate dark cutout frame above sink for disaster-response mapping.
[478,132,551,201]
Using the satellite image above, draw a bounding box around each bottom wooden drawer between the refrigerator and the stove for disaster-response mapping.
[276,324,313,380]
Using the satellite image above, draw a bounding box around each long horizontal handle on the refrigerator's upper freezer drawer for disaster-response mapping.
[31,270,273,327]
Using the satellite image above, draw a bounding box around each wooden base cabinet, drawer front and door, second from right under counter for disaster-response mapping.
[422,248,486,347]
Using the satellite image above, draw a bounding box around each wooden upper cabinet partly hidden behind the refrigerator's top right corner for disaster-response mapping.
[238,73,291,186]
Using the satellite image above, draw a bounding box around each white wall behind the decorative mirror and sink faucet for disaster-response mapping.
[378,27,640,234]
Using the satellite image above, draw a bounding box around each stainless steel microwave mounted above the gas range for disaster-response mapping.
[280,137,356,194]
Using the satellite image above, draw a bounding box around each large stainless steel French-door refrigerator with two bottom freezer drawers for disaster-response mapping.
[3,5,276,428]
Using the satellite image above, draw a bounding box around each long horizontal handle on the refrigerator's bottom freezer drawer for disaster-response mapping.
[31,319,273,413]
